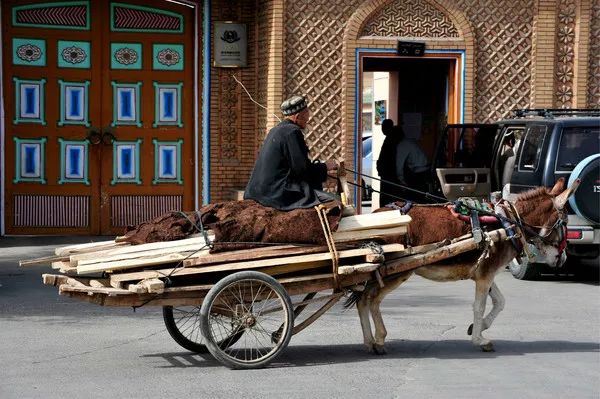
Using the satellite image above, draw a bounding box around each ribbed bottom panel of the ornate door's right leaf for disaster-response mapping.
[111,195,183,227]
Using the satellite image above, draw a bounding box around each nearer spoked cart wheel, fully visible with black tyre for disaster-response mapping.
[200,271,294,369]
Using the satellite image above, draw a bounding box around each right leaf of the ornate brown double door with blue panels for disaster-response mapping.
[100,0,194,234]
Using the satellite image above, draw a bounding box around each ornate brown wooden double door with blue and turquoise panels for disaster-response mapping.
[2,0,194,234]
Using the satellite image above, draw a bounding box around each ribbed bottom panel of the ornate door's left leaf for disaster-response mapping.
[13,195,90,227]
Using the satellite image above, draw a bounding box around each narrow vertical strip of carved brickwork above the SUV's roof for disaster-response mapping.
[554,0,577,108]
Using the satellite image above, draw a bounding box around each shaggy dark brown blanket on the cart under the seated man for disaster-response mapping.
[118,200,342,251]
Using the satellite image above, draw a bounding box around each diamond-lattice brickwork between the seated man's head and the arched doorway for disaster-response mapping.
[284,0,357,159]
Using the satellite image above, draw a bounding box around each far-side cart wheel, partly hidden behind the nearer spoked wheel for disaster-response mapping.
[163,306,244,353]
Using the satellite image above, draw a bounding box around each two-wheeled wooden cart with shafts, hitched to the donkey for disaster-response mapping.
[30,219,506,368]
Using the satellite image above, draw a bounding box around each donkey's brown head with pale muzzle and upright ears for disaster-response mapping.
[514,177,580,267]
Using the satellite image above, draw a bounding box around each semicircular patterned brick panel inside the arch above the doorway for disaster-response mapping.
[361,0,459,38]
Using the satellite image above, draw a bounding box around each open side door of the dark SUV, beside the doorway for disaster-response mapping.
[433,124,499,200]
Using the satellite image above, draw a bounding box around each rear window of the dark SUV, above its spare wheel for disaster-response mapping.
[556,127,600,172]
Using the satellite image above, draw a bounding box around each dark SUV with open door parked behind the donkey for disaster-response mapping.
[433,109,600,279]
